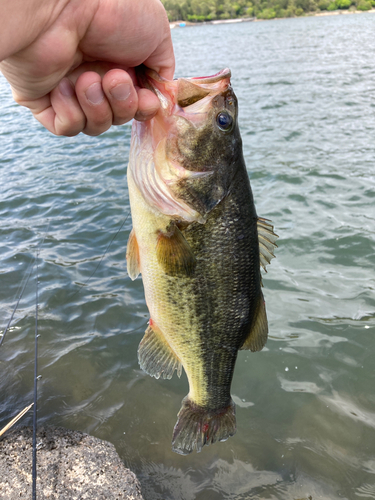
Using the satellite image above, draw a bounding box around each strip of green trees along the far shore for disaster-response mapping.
[162,0,375,22]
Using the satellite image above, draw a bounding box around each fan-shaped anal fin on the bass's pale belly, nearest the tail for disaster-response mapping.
[138,320,182,379]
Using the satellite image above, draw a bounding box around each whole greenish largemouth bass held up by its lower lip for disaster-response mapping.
[127,69,277,455]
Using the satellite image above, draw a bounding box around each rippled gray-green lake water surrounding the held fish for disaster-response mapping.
[0,13,375,500]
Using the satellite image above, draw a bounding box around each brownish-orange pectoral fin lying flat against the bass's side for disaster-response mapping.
[156,222,196,276]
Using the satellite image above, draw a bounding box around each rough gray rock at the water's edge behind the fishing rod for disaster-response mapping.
[0,427,143,500]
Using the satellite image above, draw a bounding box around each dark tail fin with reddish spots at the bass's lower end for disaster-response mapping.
[172,397,236,455]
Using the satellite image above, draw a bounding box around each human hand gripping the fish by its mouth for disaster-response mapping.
[0,0,174,136]
